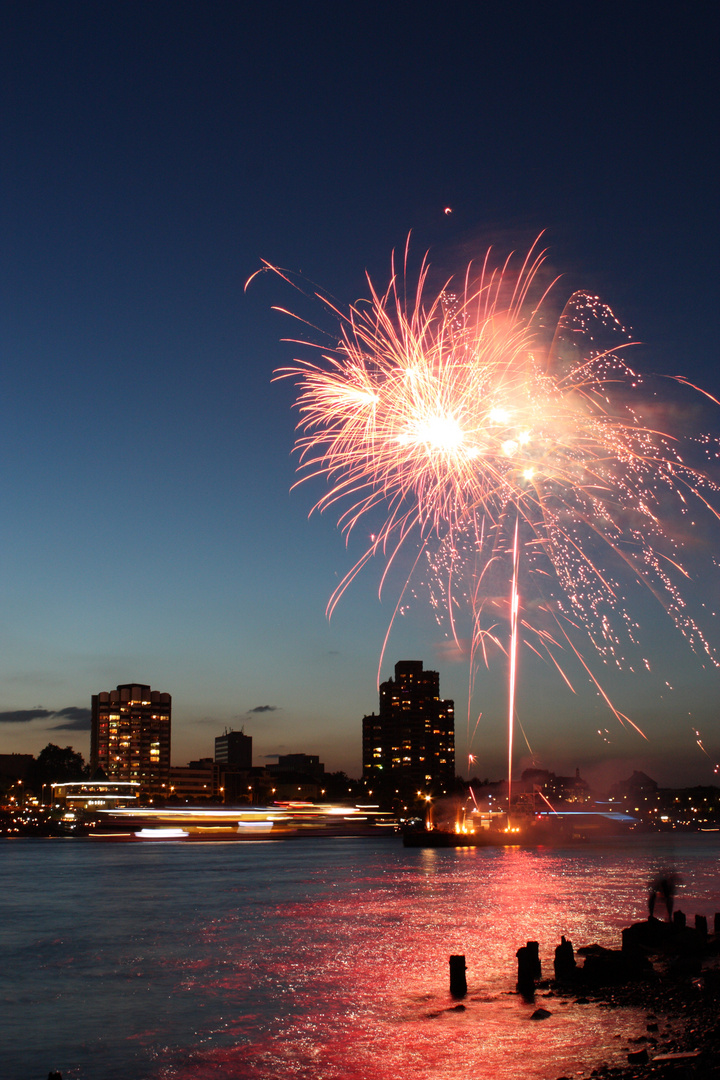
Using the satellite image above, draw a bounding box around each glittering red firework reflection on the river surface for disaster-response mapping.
[152,849,643,1080]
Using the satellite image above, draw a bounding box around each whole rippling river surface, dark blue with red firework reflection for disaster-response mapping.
[0,836,720,1080]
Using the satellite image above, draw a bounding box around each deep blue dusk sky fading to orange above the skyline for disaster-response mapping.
[0,0,720,783]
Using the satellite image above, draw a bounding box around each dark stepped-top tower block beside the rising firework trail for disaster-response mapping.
[363,660,456,795]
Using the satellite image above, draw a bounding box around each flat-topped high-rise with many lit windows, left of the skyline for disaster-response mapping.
[90,683,172,796]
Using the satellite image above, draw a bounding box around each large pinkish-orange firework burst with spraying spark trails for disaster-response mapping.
[267,238,718,786]
